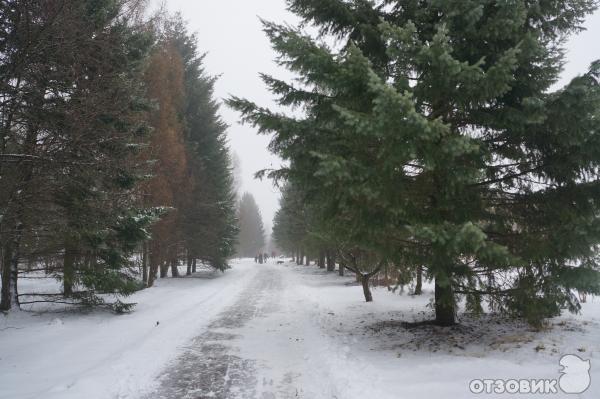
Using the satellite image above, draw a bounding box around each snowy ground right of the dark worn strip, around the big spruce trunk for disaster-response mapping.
[210,265,600,399]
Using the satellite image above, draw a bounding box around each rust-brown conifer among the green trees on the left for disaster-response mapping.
[142,37,191,286]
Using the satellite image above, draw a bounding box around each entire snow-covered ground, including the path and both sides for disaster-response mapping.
[0,260,600,399]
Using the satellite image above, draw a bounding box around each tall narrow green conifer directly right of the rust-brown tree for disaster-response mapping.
[165,15,238,270]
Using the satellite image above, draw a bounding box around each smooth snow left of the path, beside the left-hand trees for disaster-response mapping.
[0,263,257,399]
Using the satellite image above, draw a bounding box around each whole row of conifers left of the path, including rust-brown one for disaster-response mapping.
[0,0,237,310]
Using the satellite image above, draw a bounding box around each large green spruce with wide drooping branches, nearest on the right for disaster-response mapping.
[229,0,600,325]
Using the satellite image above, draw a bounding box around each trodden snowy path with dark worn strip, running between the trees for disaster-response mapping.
[148,265,335,399]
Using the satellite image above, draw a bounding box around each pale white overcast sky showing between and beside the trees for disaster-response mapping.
[154,0,600,233]
